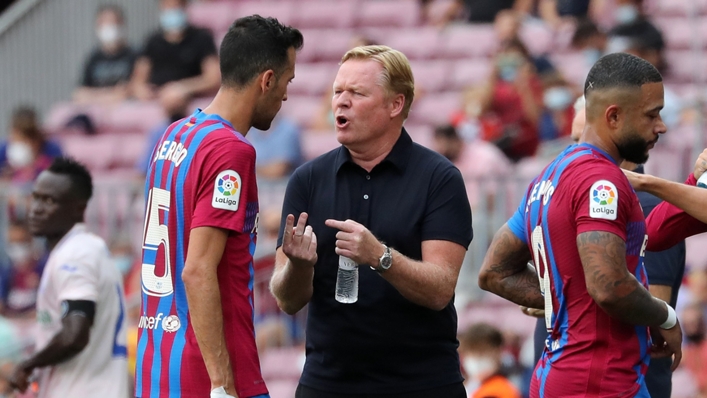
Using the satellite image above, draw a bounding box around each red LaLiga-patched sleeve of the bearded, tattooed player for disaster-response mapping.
[563,162,638,241]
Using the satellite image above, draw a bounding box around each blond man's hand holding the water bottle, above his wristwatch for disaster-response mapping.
[324,219,385,266]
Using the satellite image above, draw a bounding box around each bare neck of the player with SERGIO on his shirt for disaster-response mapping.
[204,87,255,136]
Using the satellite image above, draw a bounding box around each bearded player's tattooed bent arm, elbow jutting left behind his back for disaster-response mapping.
[479,225,544,308]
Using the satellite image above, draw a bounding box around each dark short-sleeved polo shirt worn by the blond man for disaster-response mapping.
[278,129,472,394]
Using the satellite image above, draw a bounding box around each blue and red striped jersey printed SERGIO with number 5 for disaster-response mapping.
[135,110,267,398]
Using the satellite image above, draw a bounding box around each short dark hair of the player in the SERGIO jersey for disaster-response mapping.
[219,15,304,87]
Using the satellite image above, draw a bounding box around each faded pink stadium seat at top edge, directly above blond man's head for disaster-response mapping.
[358,0,420,27]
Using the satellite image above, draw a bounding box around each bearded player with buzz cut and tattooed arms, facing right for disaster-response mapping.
[479,53,682,398]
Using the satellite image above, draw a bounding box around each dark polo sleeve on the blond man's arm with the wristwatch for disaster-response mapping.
[421,166,474,248]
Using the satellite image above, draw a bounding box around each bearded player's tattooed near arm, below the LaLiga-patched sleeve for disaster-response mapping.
[577,231,666,326]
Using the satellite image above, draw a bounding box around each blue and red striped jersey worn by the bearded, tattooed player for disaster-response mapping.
[508,144,650,398]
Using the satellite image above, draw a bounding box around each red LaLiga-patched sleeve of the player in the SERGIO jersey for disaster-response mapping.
[187,131,257,232]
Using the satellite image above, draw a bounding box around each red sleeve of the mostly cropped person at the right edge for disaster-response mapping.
[646,174,707,251]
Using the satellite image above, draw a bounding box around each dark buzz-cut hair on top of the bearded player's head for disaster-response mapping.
[584,53,663,96]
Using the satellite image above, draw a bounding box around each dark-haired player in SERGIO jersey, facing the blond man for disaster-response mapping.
[135,15,303,398]
